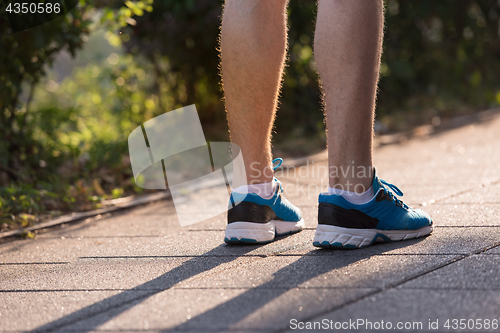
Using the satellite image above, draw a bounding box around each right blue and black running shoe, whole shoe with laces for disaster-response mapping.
[313,170,433,249]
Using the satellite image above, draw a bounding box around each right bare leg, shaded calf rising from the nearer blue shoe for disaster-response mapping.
[314,0,384,192]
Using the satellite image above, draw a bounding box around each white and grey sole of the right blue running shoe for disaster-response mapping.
[313,225,433,249]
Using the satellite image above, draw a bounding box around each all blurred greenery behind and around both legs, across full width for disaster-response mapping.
[0,0,500,230]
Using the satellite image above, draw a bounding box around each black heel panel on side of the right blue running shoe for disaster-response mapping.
[318,202,378,229]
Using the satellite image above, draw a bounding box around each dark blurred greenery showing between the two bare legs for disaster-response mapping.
[282,0,325,155]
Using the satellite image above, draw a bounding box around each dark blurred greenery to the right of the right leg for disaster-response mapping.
[377,0,500,129]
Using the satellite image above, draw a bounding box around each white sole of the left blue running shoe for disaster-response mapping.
[224,219,304,244]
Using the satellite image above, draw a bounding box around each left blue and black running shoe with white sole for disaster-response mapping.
[224,158,304,244]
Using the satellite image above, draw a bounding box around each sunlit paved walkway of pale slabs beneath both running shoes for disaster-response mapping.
[0,113,500,332]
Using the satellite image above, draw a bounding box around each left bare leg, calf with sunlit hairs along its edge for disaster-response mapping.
[220,0,287,184]
